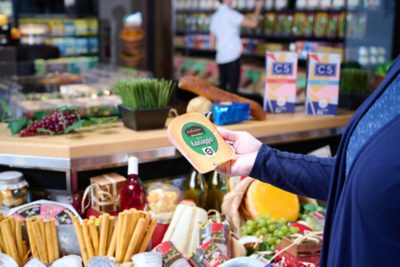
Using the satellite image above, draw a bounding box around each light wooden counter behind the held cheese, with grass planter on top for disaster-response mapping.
[0,112,352,195]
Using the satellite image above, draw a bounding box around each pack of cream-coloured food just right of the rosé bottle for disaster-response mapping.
[146,182,181,213]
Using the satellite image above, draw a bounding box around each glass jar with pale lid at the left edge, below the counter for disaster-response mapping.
[0,171,29,208]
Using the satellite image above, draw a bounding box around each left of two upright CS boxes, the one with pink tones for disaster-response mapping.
[264,52,297,113]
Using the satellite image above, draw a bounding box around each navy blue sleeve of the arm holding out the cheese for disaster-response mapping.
[249,145,335,200]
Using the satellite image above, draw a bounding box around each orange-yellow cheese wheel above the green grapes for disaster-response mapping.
[245,181,300,221]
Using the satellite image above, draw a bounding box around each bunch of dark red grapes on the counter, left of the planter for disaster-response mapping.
[19,110,78,137]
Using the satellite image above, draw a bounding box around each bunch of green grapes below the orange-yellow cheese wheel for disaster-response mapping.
[241,215,299,250]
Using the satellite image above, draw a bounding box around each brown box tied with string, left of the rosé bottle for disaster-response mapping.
[90,173,126,212]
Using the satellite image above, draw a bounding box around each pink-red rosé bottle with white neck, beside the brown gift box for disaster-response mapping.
[120,157,145,210]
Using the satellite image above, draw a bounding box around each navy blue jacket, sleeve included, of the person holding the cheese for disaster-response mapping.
[250,58,400,267]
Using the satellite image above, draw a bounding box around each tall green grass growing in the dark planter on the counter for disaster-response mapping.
[112,78,175,110]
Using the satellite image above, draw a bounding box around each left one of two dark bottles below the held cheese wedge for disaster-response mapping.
[184,170,208,208]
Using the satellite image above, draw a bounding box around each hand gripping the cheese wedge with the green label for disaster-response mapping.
[216,127,262,176]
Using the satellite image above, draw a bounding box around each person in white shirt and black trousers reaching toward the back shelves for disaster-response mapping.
[210,0,263,92]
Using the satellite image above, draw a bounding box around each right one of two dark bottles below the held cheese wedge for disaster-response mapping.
[206,172,229,214]
